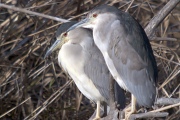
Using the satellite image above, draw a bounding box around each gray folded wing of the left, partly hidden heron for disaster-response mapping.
[84,40,110,102]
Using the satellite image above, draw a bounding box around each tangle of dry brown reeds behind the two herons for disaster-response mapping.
[0,0,180,120]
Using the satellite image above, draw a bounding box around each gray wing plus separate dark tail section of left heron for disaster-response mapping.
[84,43,126,109]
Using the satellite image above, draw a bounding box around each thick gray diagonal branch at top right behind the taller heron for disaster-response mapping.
[145,0,180,39]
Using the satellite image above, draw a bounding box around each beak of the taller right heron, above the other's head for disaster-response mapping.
[67,18,90,32]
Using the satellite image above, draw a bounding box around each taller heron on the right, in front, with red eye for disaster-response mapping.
[69,5,158,118]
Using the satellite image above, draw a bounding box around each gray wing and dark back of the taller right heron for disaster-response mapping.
[108,13,157,107]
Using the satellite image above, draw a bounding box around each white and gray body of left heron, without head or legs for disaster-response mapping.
[58,29,125,109]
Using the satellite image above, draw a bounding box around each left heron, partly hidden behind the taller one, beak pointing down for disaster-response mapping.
[45,22,125,119]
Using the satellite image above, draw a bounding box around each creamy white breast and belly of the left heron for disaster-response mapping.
[58,44,105,101]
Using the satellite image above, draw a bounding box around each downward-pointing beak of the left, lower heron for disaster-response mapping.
[44,39,62,58]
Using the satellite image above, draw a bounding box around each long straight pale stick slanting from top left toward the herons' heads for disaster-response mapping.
[0,3,68,22]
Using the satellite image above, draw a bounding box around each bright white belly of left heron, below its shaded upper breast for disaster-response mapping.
[58,44,106,102]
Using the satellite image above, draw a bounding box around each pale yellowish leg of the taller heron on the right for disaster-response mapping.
[125,94,136,120]
